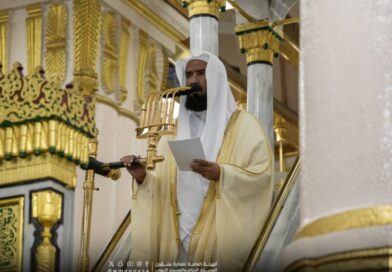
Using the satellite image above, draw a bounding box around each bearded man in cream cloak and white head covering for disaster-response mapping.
[122,52,273,271]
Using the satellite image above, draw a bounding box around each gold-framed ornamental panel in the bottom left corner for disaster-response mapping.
[0,196,24,271]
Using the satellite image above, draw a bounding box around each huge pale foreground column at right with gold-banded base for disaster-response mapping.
[284,0,392,271]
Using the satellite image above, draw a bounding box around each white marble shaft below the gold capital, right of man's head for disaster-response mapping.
[247,63,274,146]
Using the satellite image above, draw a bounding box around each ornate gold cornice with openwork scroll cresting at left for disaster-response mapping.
[0,63,96,187]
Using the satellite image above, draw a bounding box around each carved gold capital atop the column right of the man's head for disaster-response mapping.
[235,20,280,65]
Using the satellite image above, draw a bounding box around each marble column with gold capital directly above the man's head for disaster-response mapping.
[182,0,225,56]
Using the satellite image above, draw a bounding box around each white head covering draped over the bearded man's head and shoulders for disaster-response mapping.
[176,51,236,162]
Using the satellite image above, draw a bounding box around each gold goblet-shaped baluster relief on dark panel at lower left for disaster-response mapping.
[32,190,62,271]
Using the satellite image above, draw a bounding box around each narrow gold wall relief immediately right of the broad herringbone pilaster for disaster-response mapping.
[102,12,118,94]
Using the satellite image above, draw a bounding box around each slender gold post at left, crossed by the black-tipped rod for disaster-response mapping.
[77,139,98,272]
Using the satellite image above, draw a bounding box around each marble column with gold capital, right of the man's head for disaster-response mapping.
[235,21,280,146]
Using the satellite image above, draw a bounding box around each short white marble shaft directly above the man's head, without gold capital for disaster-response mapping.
[189,15,219,56]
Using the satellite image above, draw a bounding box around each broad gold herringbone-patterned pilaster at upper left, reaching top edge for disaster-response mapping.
[73,0,101,95]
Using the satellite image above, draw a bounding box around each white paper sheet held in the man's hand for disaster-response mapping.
[169,137,205,171]
